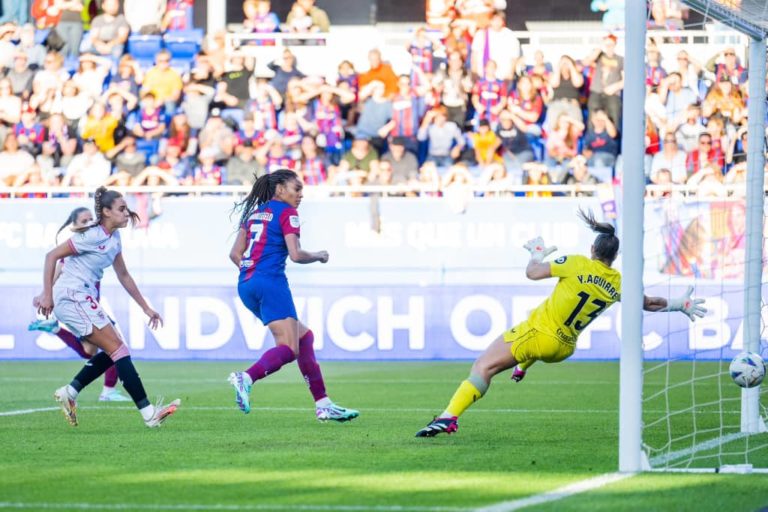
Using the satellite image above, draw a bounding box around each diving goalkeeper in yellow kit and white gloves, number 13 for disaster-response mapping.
[416,210,707,437]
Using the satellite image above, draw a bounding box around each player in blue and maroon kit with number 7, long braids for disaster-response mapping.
[229,169,360,421]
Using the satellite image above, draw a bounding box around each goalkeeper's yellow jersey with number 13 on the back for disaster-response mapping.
[528,255,621,343]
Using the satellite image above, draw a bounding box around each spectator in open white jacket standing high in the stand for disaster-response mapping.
[470,11,521,80]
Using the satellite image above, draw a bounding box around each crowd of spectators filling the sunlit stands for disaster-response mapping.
[0,0,762,195]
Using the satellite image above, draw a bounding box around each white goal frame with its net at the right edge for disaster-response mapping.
[618,0,768,472]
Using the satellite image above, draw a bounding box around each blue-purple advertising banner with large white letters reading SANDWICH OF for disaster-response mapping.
[0,282,756,360]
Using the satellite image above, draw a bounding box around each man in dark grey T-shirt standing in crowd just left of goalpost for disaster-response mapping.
[584,34,624,126]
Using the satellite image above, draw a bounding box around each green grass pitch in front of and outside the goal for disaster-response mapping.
[0,361,768,512]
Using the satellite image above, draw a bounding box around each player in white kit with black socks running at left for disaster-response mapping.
[34,187,180,427]
